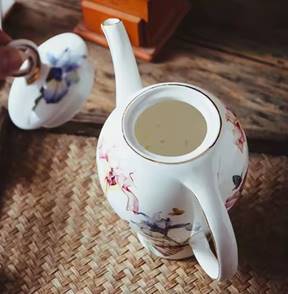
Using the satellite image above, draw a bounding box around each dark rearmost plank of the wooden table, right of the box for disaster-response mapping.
[176,26,288,69]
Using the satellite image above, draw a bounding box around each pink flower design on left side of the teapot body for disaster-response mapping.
[99,144,139,213]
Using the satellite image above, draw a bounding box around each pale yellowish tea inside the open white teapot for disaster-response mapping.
[135,100,207,156]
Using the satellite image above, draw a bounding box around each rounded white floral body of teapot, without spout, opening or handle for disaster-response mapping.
[97,83,248,259]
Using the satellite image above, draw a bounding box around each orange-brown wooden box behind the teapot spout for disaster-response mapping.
[75,0,190,60]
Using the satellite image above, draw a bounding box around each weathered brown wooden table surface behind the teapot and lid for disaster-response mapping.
[0,0,288,154]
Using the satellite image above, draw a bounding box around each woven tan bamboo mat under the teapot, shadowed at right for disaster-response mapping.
[0,132,288,294]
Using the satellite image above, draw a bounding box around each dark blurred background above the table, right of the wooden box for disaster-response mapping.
[188,0,288,29]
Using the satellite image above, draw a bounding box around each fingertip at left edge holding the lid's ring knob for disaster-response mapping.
[0,47,22,79]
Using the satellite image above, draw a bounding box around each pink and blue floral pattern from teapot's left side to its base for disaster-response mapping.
[99,142,200,256]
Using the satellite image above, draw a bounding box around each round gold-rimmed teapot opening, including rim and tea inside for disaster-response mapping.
[122,83,221,163]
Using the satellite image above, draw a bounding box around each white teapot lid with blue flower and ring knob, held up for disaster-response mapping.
[8,33,94,130]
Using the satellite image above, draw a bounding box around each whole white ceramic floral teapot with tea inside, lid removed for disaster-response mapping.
[97,19,248,280]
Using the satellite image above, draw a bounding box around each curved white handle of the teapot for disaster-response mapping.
[184,179,238,280]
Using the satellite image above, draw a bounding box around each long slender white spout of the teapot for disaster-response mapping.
[101,18,142,106]
